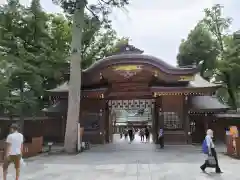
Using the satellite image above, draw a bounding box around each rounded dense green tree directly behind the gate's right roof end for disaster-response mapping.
[177,22,219,79]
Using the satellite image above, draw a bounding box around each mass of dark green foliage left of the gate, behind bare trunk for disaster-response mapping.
[0,0,127,121]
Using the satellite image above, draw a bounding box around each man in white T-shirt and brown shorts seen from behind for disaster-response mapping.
[3,124,23,180]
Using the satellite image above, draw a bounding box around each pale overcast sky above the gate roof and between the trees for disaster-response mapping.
[0,0,240,65]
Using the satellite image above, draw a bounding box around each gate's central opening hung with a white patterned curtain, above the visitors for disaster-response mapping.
[106,99,155,143]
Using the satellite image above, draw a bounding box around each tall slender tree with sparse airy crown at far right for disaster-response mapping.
[203,4,237,109]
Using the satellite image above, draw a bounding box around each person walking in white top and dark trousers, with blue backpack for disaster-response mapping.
[200,129,222,173]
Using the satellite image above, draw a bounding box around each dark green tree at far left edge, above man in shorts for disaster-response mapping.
[0,0,39,129]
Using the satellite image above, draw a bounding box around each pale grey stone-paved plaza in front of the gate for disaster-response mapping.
[1,136,240,180]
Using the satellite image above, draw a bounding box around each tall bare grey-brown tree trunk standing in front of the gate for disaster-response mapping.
[64,1,85,153]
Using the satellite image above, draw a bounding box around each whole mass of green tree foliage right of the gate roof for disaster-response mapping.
[177,4,240,109]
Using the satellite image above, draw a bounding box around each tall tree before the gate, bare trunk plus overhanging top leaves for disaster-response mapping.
[55,0,128,152]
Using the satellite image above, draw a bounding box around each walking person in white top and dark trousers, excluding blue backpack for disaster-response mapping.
[200,129,222,173]
